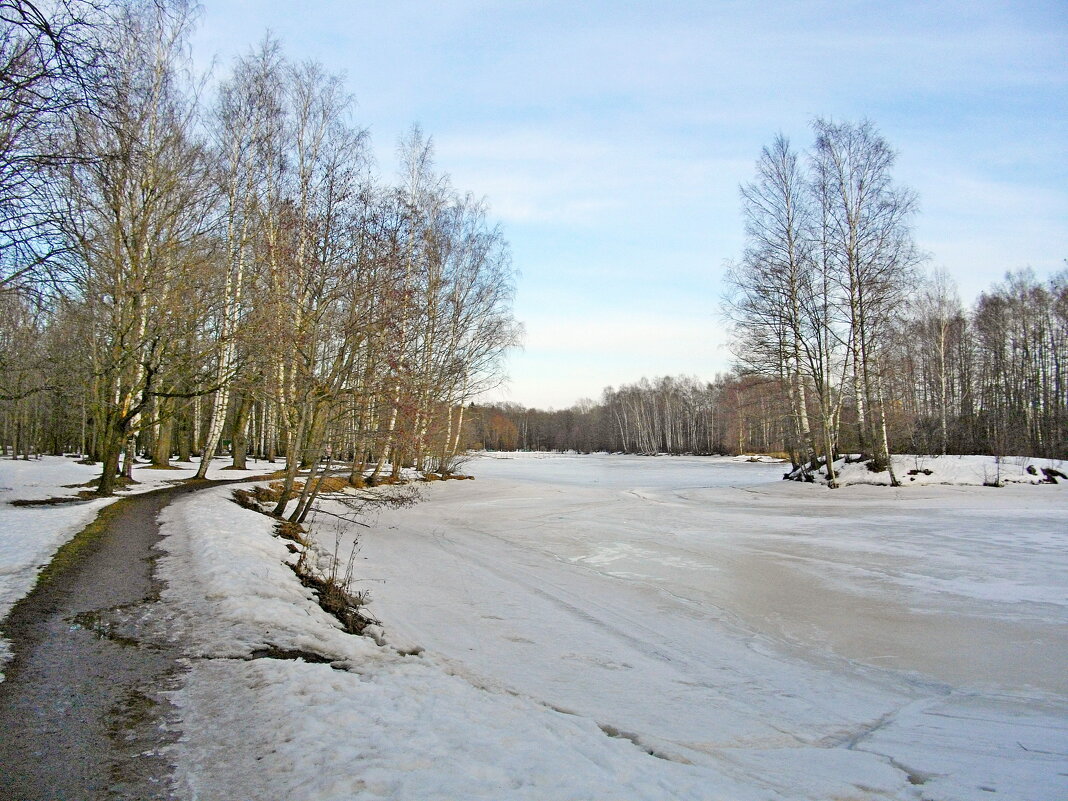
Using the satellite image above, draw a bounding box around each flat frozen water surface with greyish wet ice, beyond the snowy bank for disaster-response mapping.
[360,454,1068,801]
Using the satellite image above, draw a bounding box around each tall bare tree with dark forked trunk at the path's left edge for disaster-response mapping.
[66,2,214,494]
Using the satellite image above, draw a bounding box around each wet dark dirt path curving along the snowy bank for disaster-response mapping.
[0,485,214,801]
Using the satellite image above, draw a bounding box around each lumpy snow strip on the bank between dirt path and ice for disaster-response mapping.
[158,482,777,801]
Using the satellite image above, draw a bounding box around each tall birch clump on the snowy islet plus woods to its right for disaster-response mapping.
[726,120,1068,485]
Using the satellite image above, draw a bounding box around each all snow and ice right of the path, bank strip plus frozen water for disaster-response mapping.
[152,454,1068,801]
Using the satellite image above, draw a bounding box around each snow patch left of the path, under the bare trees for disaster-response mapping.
[0,456,279,679]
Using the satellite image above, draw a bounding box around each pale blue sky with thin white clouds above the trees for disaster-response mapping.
[192,0,1068,409]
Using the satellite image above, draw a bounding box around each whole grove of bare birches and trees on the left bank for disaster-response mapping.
[0,0,518,508]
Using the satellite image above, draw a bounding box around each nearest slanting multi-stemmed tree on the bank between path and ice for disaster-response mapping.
[258,57,367,517]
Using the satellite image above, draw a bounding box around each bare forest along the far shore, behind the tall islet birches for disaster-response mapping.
[468,269,1068,469]
